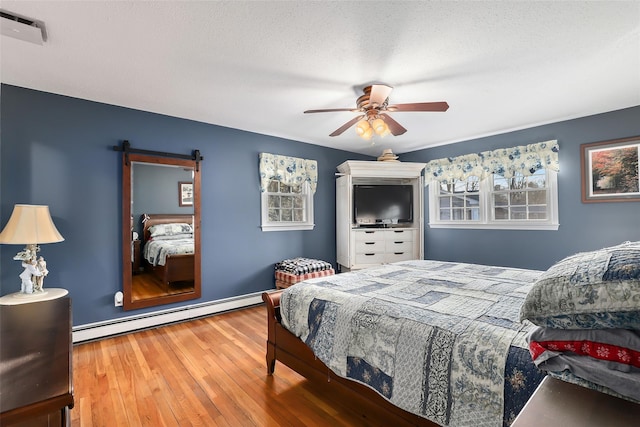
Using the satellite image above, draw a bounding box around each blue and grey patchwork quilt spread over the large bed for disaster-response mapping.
[280,260,543,427]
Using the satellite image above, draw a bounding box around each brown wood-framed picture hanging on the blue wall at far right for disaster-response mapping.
[580,136,640,203]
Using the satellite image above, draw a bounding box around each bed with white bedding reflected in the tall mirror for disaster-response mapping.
[142,214,195,287]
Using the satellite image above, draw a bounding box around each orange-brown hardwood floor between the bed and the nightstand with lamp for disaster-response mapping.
[70,306,384,427]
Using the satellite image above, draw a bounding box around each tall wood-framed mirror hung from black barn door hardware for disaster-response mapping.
[119,146,202,310]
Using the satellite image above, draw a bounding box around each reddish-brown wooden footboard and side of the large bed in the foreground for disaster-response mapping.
[262,290,438,427]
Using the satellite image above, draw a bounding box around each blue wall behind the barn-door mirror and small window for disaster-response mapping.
[0,85,367,325]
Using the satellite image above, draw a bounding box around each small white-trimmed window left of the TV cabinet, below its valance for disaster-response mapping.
[262,180,314,231]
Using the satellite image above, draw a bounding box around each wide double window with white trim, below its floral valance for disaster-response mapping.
[429,169,558,230]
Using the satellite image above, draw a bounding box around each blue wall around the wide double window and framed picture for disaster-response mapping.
[401,106,640,269]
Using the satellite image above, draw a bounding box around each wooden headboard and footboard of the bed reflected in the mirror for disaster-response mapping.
[142,214,195,287]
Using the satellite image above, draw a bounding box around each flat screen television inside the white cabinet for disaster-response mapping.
[353,184,413,227]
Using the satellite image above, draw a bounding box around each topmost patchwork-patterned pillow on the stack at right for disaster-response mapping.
[520,242,640,329]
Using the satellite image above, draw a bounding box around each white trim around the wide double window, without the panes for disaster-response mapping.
[429,169,560,230]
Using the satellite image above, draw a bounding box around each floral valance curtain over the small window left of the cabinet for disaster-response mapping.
[260,153,318,194]
